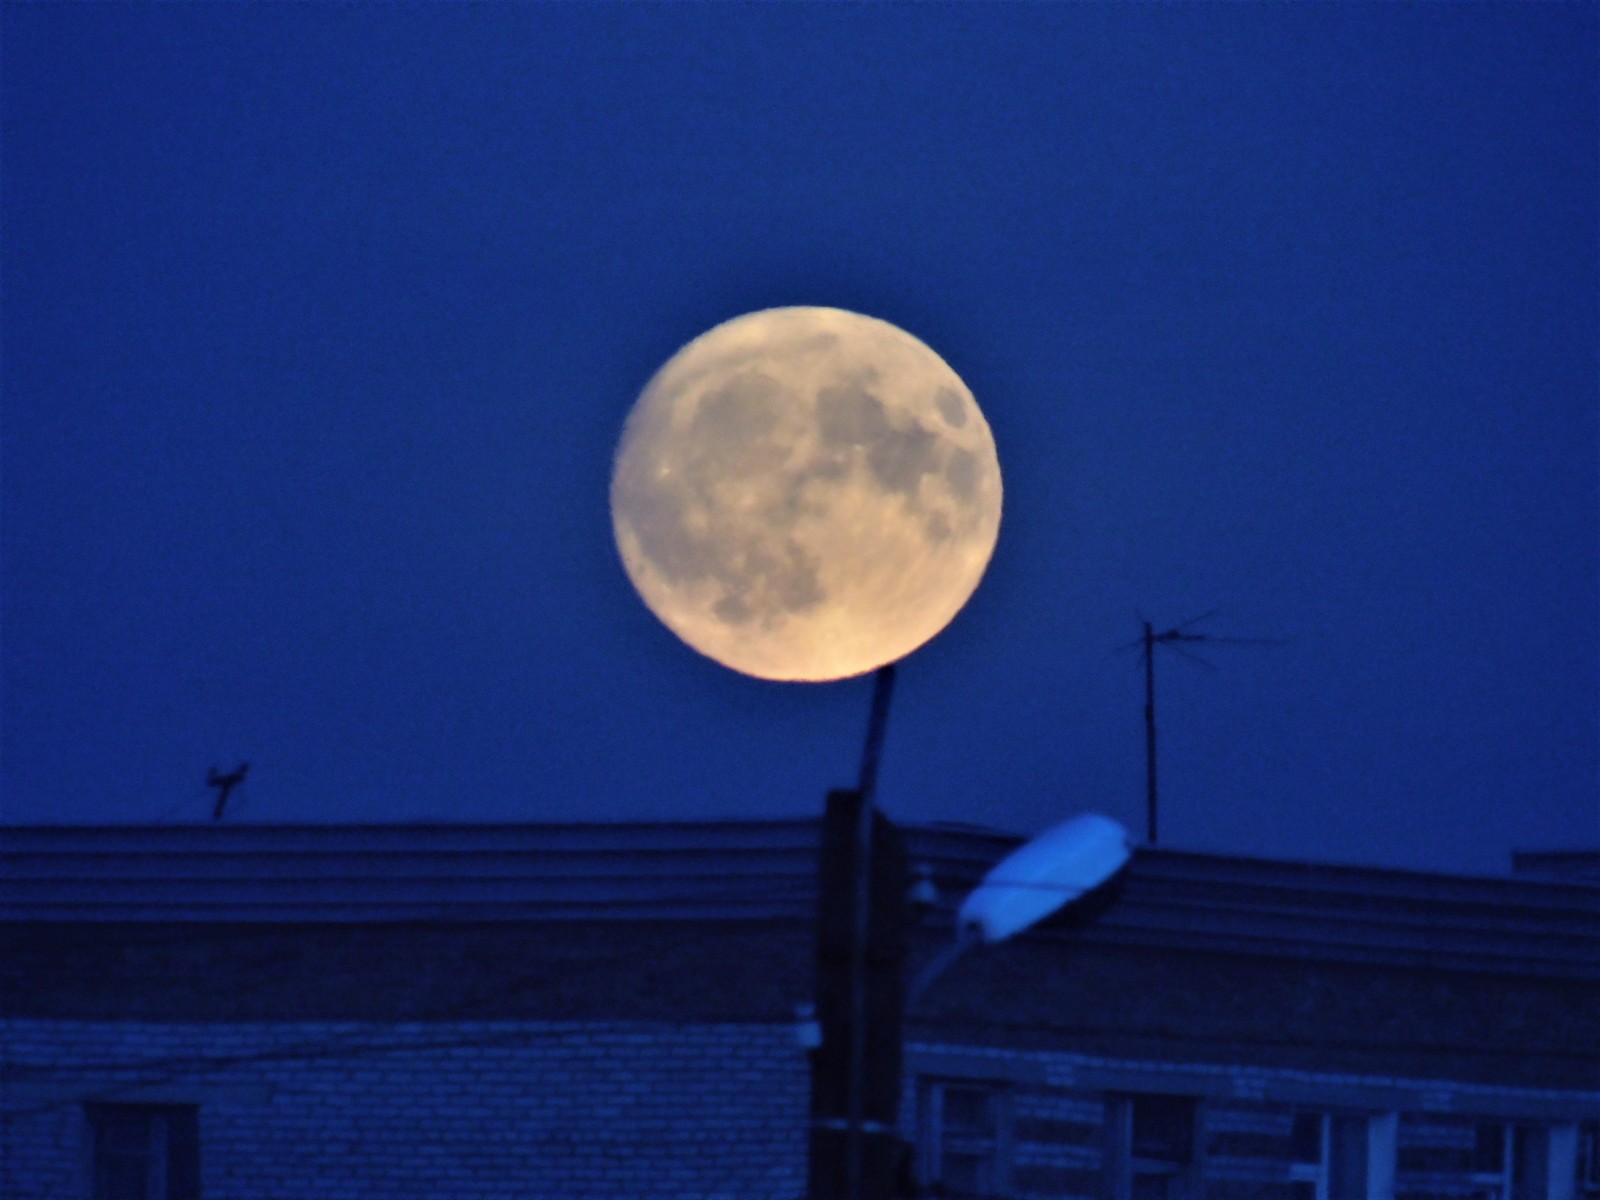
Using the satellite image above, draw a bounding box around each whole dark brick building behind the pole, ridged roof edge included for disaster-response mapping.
[0,822,1600,1200]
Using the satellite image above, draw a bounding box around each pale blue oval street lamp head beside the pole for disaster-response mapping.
[957,813,1131,944]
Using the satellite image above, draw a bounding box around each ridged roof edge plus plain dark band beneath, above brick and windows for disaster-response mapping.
[0,821,1600,1090]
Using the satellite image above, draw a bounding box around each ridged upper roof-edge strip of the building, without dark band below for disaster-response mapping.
[0,821,1600,979]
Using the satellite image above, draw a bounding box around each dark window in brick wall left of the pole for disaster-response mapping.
[85,1104,200,1200]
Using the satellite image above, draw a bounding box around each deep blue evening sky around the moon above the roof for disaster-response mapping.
[0,3,1600,872]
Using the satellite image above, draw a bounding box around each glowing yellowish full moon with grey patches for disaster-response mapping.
[611,307,1000,682]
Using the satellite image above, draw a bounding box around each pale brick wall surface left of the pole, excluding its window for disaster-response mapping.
[0,1019,810,1200]
